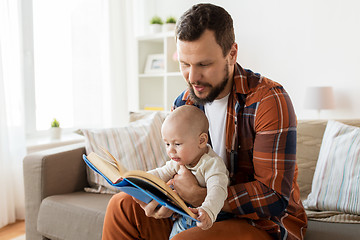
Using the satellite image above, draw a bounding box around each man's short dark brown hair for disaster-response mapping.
[175,3,235,56]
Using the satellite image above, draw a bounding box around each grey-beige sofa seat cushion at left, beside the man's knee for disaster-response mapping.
[37,192,112,240]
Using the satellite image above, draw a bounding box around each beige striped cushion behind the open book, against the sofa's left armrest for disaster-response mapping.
[81,112,167,193]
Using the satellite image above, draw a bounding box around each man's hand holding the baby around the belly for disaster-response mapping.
[173,165,206,207]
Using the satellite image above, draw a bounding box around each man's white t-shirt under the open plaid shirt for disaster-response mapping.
[204,94,230,164]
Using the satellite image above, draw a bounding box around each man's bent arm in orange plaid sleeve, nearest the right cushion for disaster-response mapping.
[225,87,296,219]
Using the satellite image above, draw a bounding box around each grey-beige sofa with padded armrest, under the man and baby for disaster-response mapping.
[24,119,360,240]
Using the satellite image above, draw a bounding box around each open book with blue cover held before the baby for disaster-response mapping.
[83,148,198,221]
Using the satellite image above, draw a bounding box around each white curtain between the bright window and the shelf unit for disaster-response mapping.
[104,0,131,126]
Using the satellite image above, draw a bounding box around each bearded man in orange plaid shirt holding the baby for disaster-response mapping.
[103,4,307,240]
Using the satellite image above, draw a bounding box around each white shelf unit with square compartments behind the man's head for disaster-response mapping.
[137,31,186,111]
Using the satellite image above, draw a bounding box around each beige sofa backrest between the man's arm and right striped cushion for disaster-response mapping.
[296,119,360,200]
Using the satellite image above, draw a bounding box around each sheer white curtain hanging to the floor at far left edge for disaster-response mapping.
[0,0,26,228]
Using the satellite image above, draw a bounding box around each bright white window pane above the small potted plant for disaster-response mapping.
[27,0,108,132]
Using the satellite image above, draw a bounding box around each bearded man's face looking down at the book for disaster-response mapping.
[177,30,237,104]
